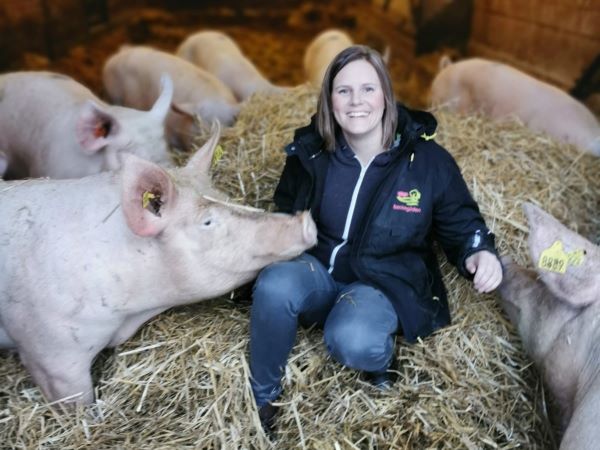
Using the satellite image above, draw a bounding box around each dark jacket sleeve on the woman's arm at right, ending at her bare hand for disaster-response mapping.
[433,155,498,279]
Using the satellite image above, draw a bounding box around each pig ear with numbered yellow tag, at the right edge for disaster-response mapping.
[523,203,600,307]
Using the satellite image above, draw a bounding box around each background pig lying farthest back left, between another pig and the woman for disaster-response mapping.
[175,31,289,102]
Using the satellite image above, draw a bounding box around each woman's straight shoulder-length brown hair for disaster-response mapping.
[317,45,398,151]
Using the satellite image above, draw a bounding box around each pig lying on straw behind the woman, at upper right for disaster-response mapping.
[430,57,600,156]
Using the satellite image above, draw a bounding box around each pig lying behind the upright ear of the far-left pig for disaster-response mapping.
[103,46,240,148]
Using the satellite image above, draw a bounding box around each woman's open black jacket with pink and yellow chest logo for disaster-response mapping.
[274,106,496,342]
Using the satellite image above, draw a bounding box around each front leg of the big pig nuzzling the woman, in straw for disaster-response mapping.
[19,348,94,404]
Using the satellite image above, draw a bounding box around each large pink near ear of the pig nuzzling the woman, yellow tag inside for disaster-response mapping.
[121,154,177,236]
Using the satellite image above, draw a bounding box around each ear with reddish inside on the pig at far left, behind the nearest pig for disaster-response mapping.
[75,100,119,155]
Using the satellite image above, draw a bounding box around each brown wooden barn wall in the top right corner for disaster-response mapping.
[468,0,600,89]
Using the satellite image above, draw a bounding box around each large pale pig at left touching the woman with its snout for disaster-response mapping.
[0,123,316,403]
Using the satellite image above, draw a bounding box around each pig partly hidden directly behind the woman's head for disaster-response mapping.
[304,29,352,87]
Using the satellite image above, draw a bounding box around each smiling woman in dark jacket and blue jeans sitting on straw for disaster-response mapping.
[250,45,502,431]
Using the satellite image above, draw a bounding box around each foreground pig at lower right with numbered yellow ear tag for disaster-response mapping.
[500,204,600,450]
